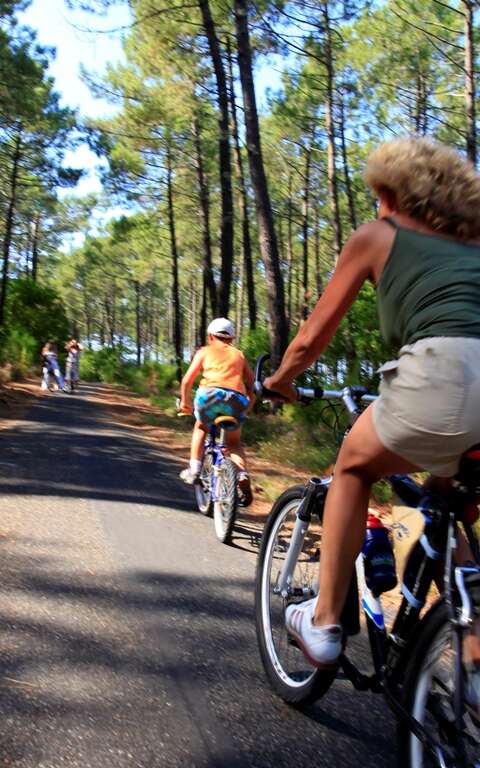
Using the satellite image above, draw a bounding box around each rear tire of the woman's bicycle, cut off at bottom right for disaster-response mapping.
[397,587,480,768]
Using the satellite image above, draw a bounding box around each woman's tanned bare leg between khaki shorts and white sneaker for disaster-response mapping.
[313,406,418,625]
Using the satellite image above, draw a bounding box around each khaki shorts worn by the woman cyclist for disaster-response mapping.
[373,337,480,477]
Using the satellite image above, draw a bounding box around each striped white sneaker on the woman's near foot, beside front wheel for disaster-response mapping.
[285,597,342,667]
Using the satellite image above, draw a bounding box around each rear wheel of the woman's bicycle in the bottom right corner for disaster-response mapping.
[398,588,480,768]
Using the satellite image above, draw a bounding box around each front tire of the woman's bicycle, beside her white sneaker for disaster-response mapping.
[255,485,337,707]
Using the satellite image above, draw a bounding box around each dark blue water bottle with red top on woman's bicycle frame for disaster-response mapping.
[362,512,397,595]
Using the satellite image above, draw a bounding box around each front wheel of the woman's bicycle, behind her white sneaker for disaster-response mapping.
[255,485,336,706]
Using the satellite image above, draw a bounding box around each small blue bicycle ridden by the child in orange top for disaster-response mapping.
[179,413,238,544]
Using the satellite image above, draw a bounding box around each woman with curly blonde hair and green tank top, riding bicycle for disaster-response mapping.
[265,138,480,705]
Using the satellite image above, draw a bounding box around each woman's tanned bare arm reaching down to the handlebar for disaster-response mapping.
[265,222,378,400]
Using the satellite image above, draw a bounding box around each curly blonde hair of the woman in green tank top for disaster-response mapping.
[364,138,480,240]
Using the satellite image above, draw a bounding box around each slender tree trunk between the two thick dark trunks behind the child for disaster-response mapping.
[227,39,257,330]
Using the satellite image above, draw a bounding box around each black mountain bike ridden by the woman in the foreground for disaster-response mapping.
[255,357,480,768]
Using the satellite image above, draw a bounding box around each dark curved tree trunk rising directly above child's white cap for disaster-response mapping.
[198,0,233,317]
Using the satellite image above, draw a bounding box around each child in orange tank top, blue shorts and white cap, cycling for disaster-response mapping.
[180,317,254,506]
